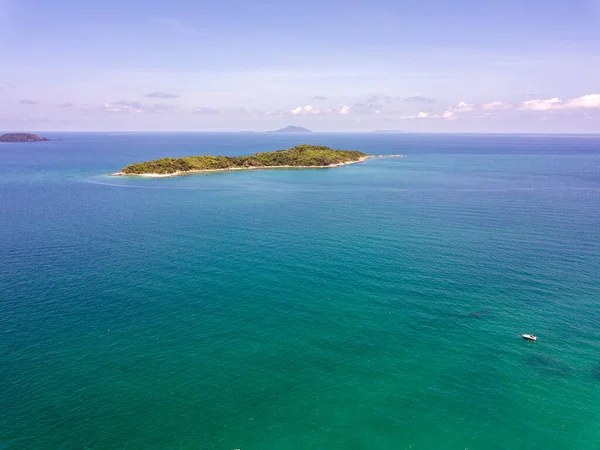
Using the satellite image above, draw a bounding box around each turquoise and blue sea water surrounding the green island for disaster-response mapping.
[0,134,600,450]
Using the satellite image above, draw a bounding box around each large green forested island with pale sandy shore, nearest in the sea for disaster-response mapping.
[113,144,371,177]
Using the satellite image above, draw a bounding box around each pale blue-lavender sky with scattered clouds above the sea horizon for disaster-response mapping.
[0,0,600,133]
